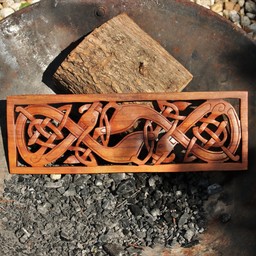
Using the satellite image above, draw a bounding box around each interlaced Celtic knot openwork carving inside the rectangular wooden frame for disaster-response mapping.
[7,94,248,172]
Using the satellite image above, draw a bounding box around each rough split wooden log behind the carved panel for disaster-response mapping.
[54,14,192,94]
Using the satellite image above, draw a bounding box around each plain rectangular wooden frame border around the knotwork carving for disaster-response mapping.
[7,91,248,174]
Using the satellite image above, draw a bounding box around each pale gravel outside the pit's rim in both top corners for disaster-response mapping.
[0,0,256,40]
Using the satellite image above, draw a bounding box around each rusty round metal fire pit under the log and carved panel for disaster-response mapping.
[0,0,256,255]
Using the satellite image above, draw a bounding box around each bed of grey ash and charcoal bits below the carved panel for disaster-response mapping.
[0,173,210,256]
